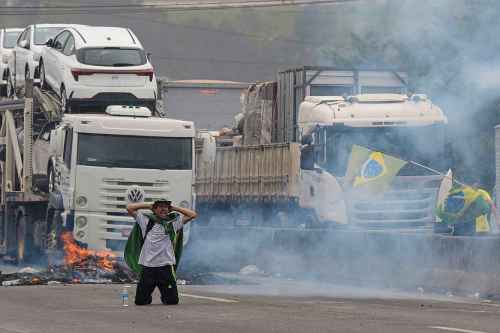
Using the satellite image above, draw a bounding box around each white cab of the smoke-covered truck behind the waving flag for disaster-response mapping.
[298,94,447,228]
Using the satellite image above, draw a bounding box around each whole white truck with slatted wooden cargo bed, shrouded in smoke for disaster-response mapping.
[197,68,450,229]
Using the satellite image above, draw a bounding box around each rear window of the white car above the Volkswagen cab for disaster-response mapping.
[78,48,147,67]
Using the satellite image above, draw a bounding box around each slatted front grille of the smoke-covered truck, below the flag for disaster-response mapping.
[348,176,442,229]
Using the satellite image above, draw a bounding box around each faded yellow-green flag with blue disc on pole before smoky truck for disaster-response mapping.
[345,145,407,195]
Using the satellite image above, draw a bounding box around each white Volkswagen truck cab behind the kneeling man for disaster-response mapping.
[47,106,195,256]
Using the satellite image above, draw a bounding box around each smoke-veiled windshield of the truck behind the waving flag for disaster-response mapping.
[316,125,447,177]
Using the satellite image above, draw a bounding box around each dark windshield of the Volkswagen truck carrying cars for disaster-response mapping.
[77,133,192,170]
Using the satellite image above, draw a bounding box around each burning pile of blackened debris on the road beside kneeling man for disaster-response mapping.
[0,232,136,286]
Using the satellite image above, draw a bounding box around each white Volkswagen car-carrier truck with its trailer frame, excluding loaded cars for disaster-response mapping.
[0,82,195,261]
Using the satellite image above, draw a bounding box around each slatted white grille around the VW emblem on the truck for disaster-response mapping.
[99,179,171,213]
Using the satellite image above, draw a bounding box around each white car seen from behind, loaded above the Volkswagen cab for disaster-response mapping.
[40,26,158,112]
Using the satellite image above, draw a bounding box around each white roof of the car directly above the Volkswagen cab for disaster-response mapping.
[67,26,142,48]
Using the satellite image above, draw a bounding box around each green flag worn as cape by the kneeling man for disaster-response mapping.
[123,212,184,274]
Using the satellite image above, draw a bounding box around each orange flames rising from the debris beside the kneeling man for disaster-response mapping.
[61,232,116,271]
